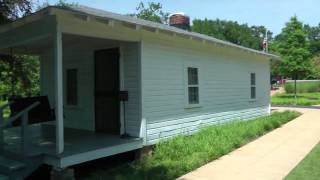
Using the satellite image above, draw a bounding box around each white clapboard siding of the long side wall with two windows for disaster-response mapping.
[141,35,270,145]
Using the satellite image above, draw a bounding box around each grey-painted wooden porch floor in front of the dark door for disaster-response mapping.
[5,124,143,167]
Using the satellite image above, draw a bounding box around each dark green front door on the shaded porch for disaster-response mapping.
[95,48,120,135]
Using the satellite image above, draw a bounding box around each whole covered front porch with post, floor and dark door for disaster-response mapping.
[0,5,146,175]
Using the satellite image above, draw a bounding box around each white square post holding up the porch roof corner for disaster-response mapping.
[54,31,64,154]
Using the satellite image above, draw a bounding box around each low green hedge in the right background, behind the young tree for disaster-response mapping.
[284,81,320,93]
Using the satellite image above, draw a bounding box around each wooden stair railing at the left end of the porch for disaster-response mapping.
[0,102,40,154]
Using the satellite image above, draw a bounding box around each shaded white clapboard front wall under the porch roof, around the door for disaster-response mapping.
[41,37,141,136]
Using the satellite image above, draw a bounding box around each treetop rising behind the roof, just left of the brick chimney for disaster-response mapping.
[130,2,169,24]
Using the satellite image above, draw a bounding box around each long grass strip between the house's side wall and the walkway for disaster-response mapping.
[87,111,300,180]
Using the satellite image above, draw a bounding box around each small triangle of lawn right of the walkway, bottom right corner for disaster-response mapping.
[285,144,320,180]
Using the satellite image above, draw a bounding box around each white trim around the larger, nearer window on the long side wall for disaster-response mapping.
[184,63,202,109]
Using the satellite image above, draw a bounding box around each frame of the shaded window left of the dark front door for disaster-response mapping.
[65,67,79,107]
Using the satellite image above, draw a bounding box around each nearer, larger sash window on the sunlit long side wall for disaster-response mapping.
[187,67,199,105]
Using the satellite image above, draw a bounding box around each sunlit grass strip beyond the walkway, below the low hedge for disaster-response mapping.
[271,93,320,106]
